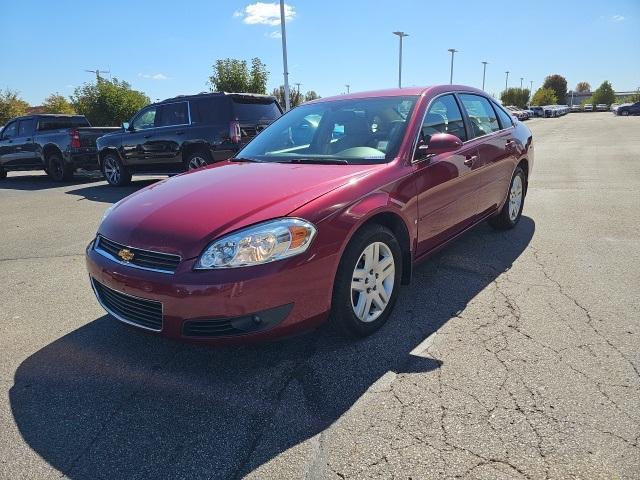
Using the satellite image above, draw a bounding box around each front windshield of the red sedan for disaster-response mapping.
[237,96,418,163]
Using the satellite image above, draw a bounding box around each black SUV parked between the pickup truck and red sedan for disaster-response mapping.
[97,93,282,186]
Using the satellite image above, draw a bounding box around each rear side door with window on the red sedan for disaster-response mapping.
[458,93,513,216]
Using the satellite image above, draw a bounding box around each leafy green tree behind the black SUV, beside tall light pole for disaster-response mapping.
[209,57,269,94]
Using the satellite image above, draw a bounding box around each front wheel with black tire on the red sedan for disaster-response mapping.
[331,224,402,337]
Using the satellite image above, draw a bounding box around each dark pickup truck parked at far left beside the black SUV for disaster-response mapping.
[0,114,120,182]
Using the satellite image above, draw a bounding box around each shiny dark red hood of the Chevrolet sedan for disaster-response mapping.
[98,162,381,259]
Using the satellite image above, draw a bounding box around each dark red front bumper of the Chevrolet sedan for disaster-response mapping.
[86,242,337,344]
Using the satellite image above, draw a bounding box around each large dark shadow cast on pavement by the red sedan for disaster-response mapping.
[10,217,535,479]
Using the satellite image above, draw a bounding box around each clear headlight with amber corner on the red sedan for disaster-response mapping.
[194,218,316,270]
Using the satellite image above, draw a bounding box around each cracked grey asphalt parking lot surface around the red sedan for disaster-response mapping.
[0,113,640,479]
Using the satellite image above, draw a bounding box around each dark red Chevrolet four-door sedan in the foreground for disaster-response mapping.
[87,85,534,343]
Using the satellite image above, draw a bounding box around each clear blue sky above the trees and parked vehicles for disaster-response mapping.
[0,0,640,104]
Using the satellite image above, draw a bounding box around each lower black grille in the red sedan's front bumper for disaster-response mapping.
[91,278,162,332]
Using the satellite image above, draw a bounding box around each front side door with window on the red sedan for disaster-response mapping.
[414,94,478,255]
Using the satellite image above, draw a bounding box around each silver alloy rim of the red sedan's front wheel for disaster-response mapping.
[351,242,395,323]
